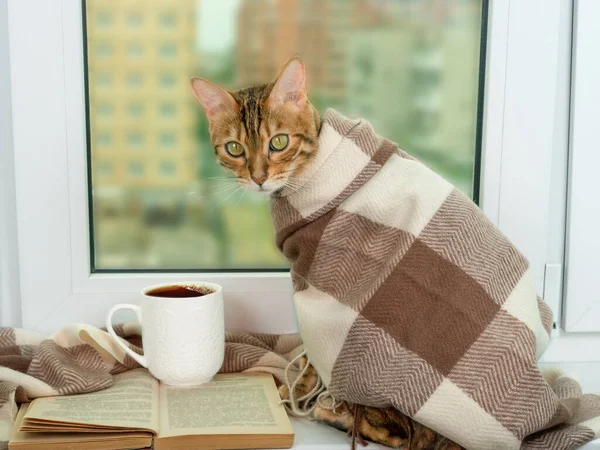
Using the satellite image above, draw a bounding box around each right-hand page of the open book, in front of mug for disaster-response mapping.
[159,374,293,438]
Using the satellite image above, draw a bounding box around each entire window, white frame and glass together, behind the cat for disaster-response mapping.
[10,0,600,380]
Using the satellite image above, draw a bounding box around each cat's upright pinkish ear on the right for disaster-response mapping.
[269,56,306,110]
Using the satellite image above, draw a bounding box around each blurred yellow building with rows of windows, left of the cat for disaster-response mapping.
[86,0,197,201]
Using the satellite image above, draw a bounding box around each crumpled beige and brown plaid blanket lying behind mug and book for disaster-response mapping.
[0,324,302,450]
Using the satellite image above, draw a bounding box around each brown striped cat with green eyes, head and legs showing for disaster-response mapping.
[191,57,462,450]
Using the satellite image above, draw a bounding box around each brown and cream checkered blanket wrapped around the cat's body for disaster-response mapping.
[271,110,600,450]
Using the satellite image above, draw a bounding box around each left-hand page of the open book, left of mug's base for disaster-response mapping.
[25,369,158,433]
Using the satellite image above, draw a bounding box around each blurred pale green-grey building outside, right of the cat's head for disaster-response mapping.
[346,0,480,170]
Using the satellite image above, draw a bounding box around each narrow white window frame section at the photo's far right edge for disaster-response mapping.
[564,0,600,332]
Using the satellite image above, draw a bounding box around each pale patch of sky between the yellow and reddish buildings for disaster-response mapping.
[196,0,240,52]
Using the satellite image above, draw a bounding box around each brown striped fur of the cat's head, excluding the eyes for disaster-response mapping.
[192,58,320,193]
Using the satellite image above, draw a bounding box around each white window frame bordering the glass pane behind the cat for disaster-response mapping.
[0,0,600,361]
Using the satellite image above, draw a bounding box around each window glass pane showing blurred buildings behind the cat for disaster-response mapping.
[85,0,484,270]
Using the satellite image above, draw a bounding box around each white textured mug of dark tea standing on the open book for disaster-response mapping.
[106,282,225,386]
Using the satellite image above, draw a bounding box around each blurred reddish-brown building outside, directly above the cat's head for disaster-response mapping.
[237,0,389,106]
